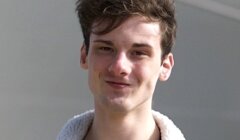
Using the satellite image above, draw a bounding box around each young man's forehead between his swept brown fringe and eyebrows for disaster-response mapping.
[90,16,161,43]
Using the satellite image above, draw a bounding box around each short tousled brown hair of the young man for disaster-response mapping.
[76,0,177,57]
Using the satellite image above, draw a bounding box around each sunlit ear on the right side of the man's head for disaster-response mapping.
[159,53,174,81]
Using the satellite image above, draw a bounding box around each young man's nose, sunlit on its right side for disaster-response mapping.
[108,53,131,76]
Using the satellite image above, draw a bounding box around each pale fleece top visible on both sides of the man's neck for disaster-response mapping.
[57,110,185,140]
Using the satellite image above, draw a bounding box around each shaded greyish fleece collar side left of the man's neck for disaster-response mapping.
[57,110,94,140]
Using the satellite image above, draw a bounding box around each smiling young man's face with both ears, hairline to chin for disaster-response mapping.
[81,16,173,111]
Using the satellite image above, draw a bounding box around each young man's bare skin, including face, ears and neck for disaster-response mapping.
[81,16,174,140]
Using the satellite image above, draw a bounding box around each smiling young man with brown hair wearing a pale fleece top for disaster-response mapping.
[57,0,185,140]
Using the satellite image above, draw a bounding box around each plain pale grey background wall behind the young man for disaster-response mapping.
[0,0,240,140]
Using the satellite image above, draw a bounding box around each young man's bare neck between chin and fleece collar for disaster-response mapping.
[86,106,160,140]
